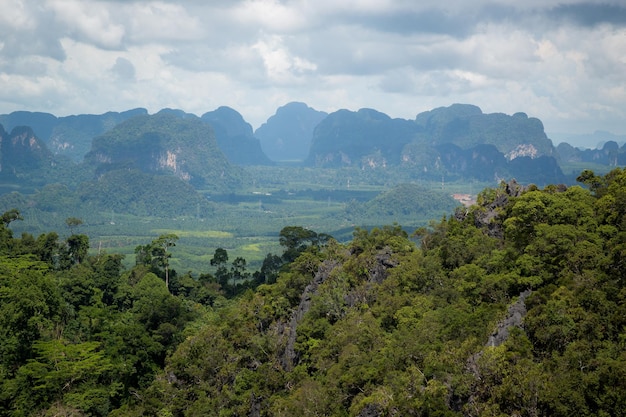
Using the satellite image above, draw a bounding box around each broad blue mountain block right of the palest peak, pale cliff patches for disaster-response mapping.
[307,104,566,184]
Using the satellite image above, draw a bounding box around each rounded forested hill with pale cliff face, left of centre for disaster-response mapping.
[85,111,240,189]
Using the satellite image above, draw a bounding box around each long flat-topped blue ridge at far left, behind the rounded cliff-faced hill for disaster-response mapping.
[0,108,148,162]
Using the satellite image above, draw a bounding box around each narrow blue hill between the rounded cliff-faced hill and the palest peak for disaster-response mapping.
[201,106,272,165]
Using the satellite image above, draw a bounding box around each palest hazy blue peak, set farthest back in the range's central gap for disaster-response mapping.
[254,102,328,161]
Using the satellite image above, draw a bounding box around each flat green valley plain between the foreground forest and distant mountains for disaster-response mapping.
[3,166,497,274]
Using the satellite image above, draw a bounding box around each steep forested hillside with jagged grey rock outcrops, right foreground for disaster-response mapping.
[111,170,626,417]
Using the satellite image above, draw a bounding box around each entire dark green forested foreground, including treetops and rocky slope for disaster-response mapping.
[0,168,626,417]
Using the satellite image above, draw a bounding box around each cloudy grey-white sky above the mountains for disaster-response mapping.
[0,0,626,142]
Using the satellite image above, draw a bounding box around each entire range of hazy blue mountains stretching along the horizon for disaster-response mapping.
[0,102,626,189]
